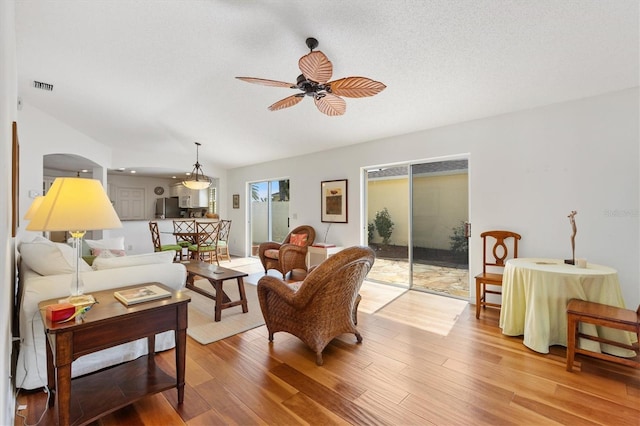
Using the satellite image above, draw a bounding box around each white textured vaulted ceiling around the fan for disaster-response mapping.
[16,0,639,176]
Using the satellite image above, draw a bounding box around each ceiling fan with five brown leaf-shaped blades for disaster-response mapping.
[236,37,387,116]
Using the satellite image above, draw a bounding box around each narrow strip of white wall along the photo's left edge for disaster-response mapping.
[0,1,16,425]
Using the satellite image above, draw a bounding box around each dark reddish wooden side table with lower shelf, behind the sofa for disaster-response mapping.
[39,283,191,426]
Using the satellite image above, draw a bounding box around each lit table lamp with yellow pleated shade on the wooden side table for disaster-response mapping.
[26,178,122,303]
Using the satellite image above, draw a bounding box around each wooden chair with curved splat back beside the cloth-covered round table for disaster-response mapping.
[475,231,521,318]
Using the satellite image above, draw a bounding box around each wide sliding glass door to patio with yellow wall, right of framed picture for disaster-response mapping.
[365,158,469,298]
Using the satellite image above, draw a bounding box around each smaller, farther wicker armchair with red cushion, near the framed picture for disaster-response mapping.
[258,225,316,278]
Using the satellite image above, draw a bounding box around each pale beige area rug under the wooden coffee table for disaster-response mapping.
[185,280,264,345]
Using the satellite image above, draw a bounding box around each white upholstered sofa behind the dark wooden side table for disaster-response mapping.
[16,238,187,389]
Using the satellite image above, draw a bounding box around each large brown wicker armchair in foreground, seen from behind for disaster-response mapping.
[258,246,375,365]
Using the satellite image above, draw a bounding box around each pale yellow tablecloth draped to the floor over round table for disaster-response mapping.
[500,258,635,357]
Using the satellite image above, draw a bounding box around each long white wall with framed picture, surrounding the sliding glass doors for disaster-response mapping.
[227,87,640,308]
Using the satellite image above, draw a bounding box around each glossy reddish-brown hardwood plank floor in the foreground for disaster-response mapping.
[15,298,640,425]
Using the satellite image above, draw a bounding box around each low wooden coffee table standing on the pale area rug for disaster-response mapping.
[184,261,249,321]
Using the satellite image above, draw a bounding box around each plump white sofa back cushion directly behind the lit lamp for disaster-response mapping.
[20,236,91,275]
